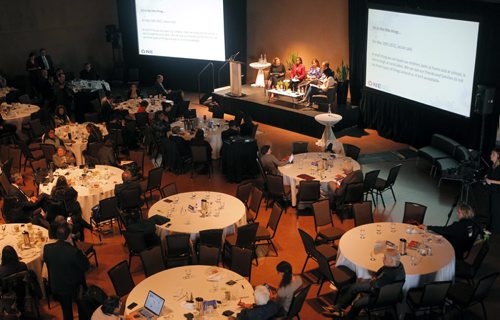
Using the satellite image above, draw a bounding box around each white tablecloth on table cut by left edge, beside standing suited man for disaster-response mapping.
[0,223,49,296]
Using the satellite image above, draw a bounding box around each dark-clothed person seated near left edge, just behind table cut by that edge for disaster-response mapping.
[9,173,49,229]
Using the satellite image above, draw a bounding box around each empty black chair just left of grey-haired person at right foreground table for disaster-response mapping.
[316,253,356,300]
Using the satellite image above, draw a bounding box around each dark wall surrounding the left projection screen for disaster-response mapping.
[118,0,250,91]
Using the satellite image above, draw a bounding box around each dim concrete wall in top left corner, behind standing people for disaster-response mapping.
[0,0,118,82]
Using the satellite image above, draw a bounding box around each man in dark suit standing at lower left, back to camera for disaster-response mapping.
[43,222,90,320]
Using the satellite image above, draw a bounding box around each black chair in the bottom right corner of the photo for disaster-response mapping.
[447,272,500,319]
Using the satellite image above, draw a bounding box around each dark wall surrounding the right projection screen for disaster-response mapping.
[349,0,500,153]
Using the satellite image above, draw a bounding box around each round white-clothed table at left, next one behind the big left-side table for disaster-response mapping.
[56,122,108,165]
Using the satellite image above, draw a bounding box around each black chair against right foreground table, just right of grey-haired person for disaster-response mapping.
[406,281,451,316]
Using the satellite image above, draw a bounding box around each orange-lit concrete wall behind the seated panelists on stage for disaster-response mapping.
[247,0,349,82]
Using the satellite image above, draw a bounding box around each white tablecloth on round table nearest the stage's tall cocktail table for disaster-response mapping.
[278,152,361,206]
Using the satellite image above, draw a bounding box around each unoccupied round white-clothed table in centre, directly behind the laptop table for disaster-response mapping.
[149,191,246,241]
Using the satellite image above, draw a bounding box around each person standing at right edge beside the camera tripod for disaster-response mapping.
[485,148,500,233]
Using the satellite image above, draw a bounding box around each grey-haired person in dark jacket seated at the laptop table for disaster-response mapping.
[236,286,278,320]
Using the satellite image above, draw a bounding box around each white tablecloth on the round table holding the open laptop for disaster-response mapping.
[125,265,255,320]
